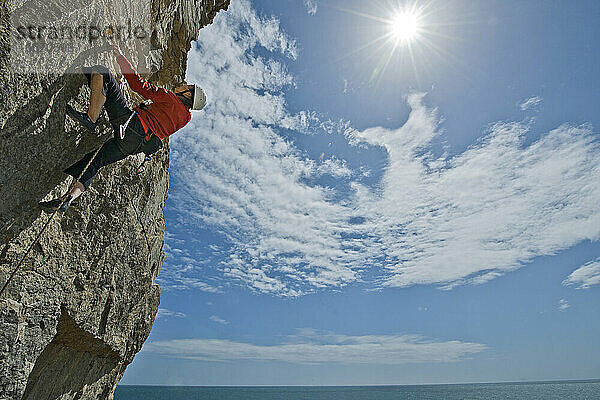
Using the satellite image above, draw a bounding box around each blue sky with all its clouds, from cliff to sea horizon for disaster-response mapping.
[122,0,600,385]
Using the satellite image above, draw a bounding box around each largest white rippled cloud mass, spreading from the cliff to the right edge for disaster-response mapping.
[161,1,600,296]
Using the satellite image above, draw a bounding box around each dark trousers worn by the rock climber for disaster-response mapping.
[65,65,162,189]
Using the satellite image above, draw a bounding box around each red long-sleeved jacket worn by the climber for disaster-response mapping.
[117,56,192,139]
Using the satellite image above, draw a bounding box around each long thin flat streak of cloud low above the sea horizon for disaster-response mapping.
[143,329,487,365]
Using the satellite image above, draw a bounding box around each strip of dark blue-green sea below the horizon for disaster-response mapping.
[115,380,600,400]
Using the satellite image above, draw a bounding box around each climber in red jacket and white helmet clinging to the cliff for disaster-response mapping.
[39,45,206,212]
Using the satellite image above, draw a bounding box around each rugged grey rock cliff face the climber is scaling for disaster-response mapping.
[0,0,229,400]
